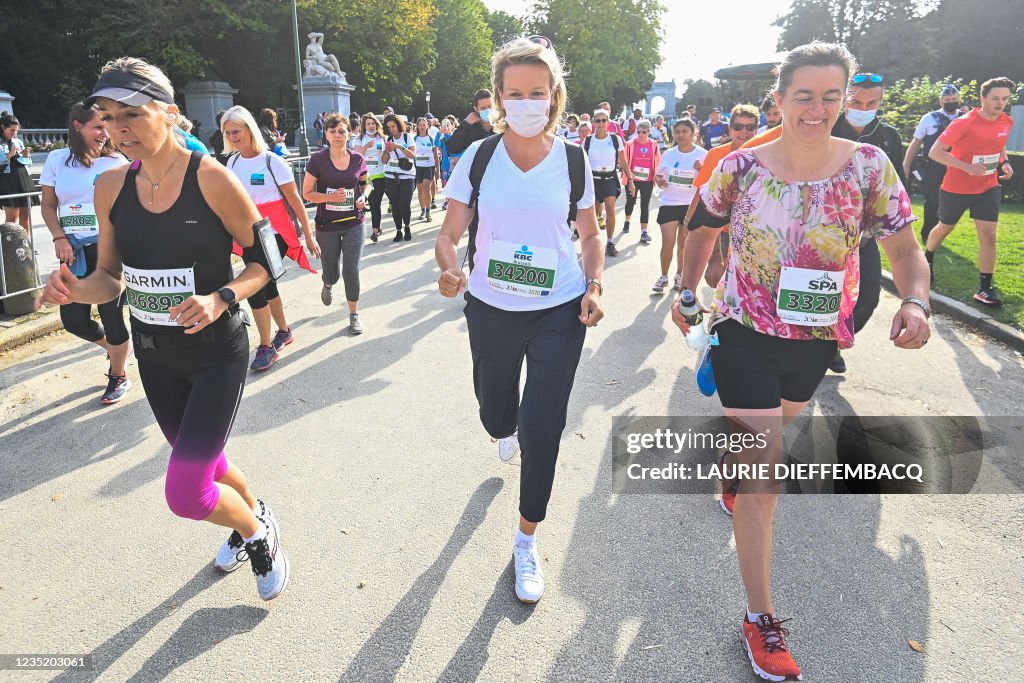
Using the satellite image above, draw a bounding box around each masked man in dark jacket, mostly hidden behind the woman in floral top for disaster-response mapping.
[828,74,906,373]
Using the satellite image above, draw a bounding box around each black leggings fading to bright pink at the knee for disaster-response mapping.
[133,315,249,519]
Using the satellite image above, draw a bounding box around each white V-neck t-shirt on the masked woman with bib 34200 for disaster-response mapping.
[444,137,594,310]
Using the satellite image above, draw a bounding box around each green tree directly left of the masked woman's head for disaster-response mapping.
[413,0,494,117]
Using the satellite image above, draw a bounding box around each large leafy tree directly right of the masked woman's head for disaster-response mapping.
[527,0,665,112]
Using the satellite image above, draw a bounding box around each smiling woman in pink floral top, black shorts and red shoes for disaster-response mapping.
[672,43,931,681]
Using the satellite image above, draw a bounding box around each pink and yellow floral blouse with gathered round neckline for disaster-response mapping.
[700,143,915,348]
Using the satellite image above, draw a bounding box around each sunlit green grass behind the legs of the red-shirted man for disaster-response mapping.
[882,200,1024,330]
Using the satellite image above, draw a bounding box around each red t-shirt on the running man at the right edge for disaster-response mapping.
[938,109,1014,195]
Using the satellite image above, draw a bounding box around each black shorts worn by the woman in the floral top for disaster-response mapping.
[711,319,837,409]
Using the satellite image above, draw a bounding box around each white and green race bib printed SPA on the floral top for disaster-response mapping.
[776,266,845,328]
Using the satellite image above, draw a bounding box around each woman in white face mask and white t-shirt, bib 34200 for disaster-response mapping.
[434,36,604,603]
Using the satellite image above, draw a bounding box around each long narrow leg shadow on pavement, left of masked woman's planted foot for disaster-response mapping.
[340,477,508,683]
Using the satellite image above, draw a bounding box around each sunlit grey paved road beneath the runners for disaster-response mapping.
[0,193,1024,682]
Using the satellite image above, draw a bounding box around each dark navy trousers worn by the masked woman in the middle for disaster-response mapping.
[464,294,587,522]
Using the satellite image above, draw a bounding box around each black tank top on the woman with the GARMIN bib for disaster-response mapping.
[111,152,234,334]
